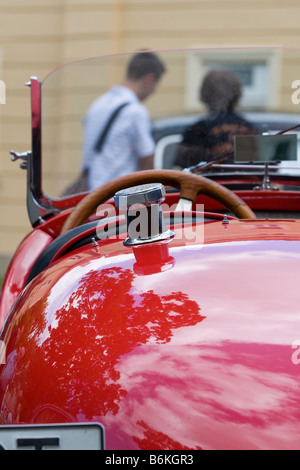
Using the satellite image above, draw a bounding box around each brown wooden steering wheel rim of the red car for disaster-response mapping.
[61,170,256,234]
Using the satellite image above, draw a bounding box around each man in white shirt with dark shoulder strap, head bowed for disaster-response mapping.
[82,51,165,190]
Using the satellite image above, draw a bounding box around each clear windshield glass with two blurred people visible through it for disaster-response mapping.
[41,48,300,198]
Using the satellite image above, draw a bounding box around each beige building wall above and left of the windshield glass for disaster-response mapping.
[0,0,300,274]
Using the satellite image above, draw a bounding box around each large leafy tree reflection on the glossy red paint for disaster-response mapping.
[2,267,204,436]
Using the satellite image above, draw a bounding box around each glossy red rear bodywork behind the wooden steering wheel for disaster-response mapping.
[0,220,300,450]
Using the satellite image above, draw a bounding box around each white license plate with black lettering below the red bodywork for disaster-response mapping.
[0,423,104,450]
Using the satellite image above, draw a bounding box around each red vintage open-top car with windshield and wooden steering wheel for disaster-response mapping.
[0,48,300,451]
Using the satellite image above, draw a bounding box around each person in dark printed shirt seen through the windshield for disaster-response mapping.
[174,70,255,168]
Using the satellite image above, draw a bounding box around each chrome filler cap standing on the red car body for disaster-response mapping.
[114,183,174,246]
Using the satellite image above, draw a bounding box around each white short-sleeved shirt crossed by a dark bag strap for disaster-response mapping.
[82,86,155,190]
